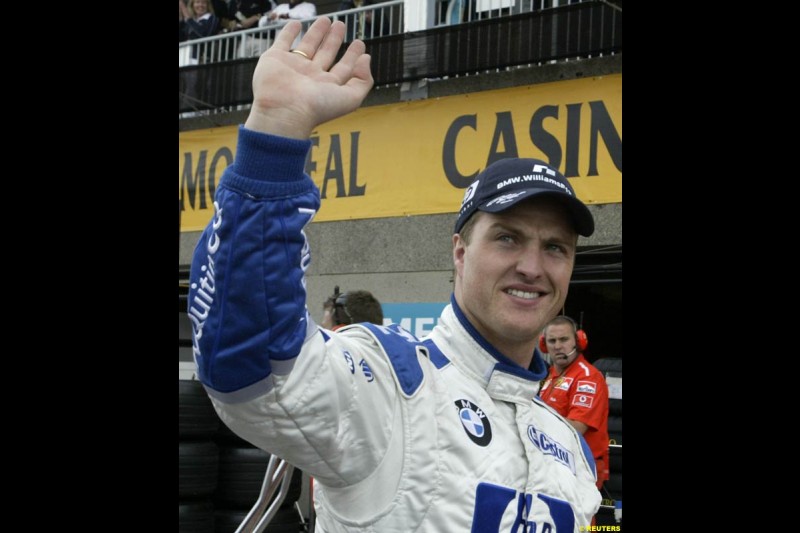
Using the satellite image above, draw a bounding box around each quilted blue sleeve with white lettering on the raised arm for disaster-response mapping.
[187,127,320,402]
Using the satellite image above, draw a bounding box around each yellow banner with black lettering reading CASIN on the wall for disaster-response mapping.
[179,74,622,231]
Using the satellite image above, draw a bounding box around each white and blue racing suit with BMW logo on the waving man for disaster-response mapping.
[188,127,600,533]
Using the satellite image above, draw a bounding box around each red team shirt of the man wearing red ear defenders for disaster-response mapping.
[539,354,608,489]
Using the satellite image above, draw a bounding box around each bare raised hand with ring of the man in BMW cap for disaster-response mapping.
[244,16,374,139]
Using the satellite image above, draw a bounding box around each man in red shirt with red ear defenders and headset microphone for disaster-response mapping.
[539,316,608,489]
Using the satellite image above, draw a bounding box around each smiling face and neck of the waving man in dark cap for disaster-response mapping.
[453,198,577,366]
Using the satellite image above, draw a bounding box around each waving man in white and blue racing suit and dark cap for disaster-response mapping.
[188,17,601,533]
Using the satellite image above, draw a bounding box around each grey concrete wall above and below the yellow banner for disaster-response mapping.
[180,54,622,321]
